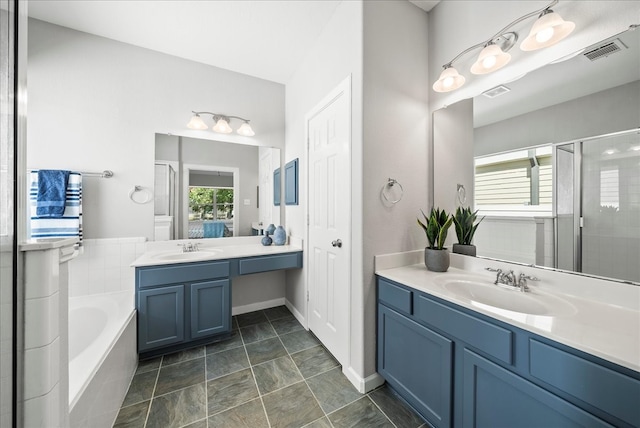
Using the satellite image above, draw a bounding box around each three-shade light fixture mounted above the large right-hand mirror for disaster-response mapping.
[433,0,575,92]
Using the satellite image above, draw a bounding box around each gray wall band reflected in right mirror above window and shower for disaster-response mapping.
[473,81,640,156]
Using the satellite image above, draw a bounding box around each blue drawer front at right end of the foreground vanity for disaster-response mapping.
[529,339,640,426]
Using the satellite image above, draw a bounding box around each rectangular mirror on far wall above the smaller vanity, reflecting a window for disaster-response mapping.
[154,134,281,241]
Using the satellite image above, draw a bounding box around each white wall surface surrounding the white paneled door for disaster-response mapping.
[284,1,362,353]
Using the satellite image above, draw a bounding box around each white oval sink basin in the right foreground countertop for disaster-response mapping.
[435,275,576,317]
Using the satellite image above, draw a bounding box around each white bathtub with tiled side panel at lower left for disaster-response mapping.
[69,291,137,428]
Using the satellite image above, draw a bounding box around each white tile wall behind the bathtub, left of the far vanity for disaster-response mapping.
[69,237,147,297]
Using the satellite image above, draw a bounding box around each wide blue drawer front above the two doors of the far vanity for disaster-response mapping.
[136,261,229,288]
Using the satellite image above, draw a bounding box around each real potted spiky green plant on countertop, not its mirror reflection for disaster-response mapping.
[418,208,453,272]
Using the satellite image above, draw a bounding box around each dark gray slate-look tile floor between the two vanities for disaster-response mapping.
[114,306,426,428]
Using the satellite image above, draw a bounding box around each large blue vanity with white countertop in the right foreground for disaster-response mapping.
[376,251,640,427]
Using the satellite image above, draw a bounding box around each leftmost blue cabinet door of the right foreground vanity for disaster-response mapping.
[378,305,453,427]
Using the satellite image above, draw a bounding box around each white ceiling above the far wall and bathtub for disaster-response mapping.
[29,0,438,84]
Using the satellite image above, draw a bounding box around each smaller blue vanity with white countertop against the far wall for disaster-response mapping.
[133,244,302,359]
